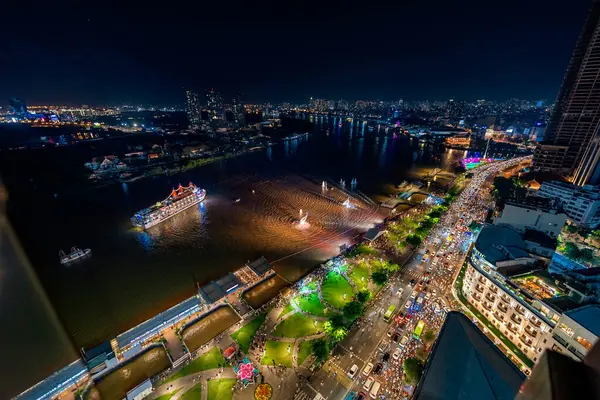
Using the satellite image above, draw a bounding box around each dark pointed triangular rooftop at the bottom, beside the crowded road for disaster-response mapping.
[414,312,525,400]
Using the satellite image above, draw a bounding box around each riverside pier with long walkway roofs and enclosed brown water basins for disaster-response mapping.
[27,257,278,400]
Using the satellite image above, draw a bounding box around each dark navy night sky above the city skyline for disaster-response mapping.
[0,0,589,106]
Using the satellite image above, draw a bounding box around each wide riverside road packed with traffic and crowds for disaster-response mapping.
[295,156,528,400]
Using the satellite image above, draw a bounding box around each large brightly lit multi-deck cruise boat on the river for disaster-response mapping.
[131,182,206,229]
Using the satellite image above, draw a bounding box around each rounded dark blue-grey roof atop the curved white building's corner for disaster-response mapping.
[475,225,530,264]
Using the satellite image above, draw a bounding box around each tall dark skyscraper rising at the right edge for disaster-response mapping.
[533,0,600,185]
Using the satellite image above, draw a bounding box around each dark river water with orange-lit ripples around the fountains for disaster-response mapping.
[9,121,464,349]
